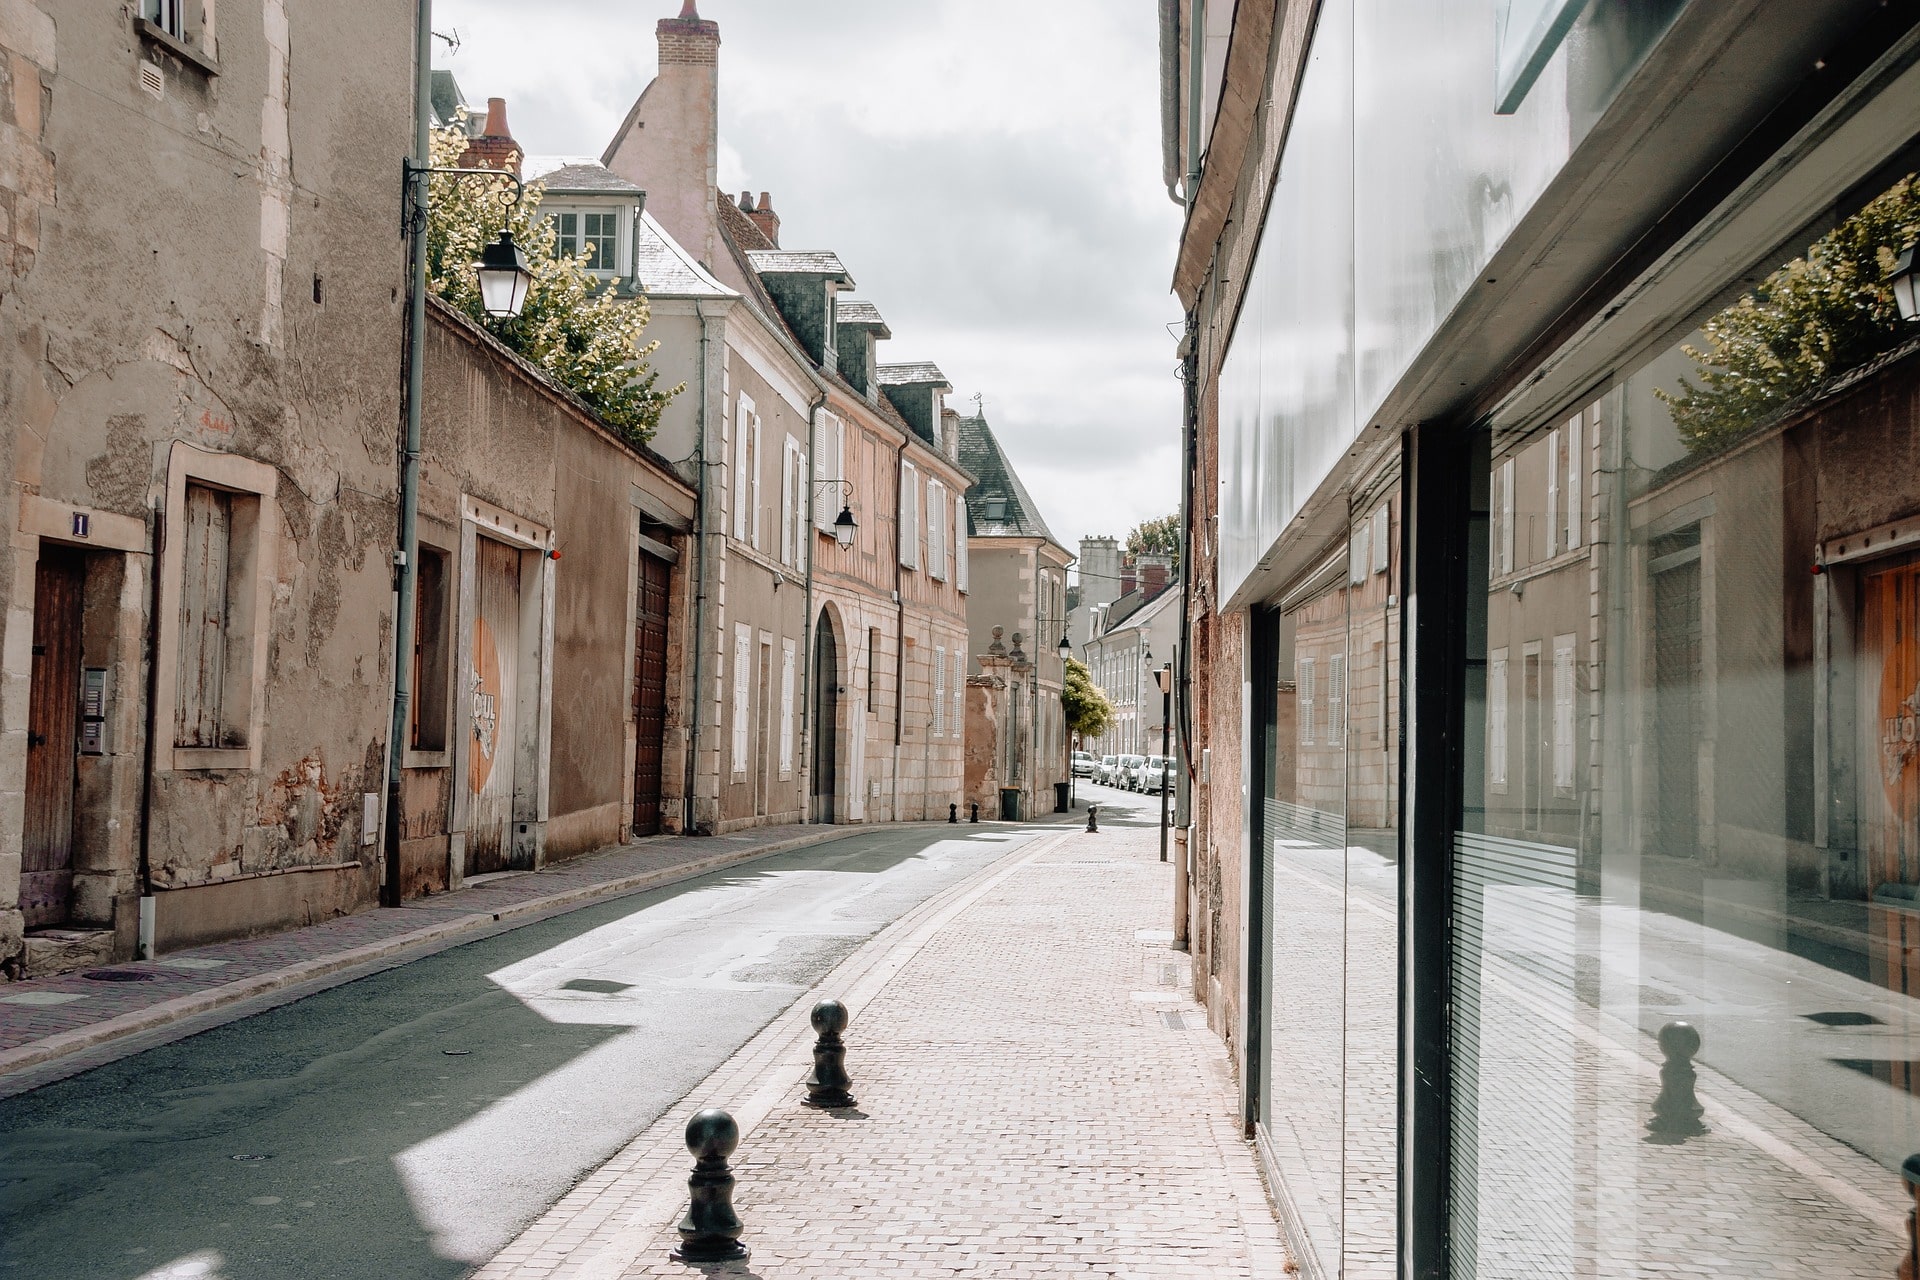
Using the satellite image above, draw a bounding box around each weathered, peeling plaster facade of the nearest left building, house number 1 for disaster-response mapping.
[0,0,413,973]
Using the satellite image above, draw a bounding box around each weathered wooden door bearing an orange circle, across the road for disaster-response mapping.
[467,537,520,875]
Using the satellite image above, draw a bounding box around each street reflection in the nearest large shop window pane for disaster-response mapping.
[1452,172,1920,1278]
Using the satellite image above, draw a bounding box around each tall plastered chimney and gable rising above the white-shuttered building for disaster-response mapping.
[601,0,724,267]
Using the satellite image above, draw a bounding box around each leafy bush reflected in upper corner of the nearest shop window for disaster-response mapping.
[1655,175,1920,451]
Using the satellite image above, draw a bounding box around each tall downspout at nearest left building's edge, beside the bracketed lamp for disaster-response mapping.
[380,0,434,906]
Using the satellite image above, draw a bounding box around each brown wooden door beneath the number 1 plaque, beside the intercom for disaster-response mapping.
[19,547,86,927]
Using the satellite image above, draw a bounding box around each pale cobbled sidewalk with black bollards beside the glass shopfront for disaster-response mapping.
[478,827,1286,1280]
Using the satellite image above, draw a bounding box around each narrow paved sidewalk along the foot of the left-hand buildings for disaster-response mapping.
[0,825,879,1096]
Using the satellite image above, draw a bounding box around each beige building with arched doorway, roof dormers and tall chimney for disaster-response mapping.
[603,4,968,829]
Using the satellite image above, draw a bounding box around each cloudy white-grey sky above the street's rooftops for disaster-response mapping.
[434,0,1181,571]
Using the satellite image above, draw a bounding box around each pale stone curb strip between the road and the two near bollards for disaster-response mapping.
[472,823,1081,1280]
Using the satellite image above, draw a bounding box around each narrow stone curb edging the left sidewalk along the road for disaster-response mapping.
[0,821,883,1080]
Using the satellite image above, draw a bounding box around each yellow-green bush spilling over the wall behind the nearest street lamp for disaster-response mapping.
[426,127,685,443]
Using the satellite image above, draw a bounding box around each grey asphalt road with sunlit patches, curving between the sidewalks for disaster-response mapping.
[0,805,1158,1280]
